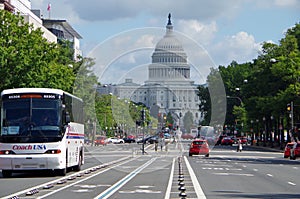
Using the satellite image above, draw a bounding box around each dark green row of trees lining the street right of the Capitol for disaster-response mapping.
[199,24,300,138]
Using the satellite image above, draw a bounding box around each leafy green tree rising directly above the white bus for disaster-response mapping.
[0,10,75,91]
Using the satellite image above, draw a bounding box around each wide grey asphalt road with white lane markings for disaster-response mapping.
[0,141,300,199]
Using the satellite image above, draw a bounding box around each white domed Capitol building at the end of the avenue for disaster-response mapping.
[100,15,201,129]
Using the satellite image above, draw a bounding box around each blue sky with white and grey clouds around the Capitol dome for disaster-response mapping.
[31,0,300,84]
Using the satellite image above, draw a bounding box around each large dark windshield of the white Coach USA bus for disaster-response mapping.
[0,98,62,143]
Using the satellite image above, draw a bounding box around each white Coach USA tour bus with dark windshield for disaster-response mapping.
[0,88,84,177]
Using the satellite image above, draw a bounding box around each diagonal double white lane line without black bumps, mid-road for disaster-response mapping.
[94,158,157,199]
